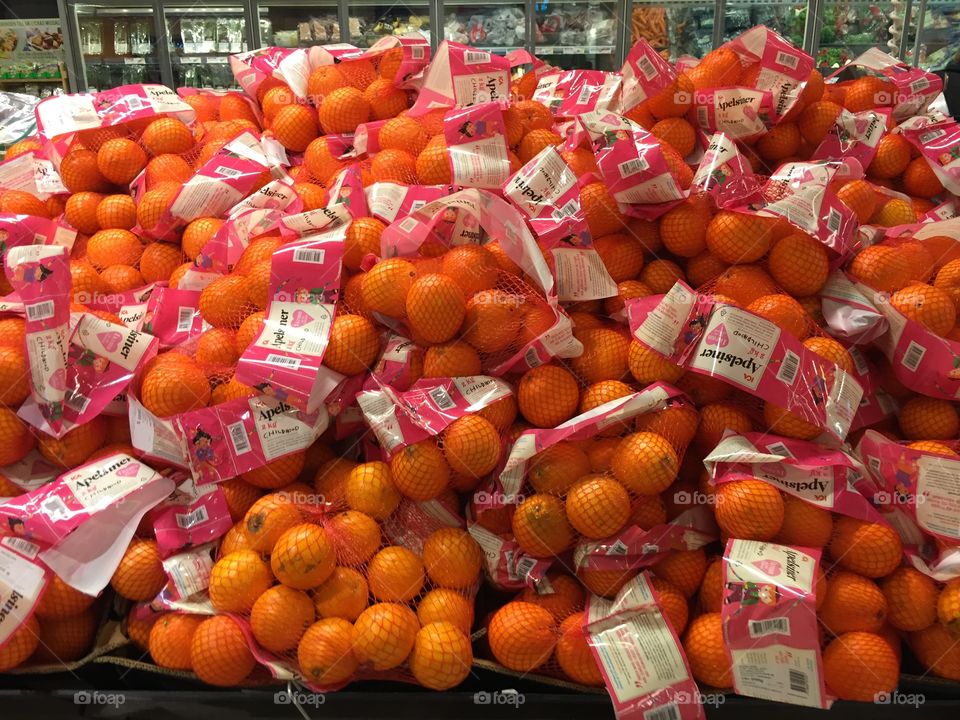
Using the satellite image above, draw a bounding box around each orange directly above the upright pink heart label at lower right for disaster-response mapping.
[714,478,784,540]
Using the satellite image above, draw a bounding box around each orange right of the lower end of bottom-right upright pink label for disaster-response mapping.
[823,632,900,702]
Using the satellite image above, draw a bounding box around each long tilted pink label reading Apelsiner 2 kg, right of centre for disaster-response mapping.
[627,282,863,440]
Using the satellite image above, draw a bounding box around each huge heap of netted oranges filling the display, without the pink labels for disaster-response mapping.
[0,26,960,701]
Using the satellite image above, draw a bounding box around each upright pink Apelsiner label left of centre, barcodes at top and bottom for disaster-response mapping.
[236,230,343,412]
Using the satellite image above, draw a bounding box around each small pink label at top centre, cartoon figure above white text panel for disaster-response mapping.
[443,102,510,188]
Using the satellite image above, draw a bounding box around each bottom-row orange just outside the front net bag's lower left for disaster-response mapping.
[190,615,257,687]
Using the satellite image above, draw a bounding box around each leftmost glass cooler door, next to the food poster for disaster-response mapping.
[68,3,163,92]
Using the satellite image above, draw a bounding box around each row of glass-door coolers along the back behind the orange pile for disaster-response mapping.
[58,0,948,90]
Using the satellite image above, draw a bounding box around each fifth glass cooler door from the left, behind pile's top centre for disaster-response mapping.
[440,0,528,54]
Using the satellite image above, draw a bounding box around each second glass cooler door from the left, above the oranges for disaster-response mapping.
[164,5,248,88]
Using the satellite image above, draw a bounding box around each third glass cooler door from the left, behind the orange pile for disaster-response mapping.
[257,0,347,47]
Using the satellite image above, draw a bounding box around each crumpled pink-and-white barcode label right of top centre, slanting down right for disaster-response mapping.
[579,113,684,220]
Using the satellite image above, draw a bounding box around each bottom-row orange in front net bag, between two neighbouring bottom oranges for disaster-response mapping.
[353,602,420,670]
